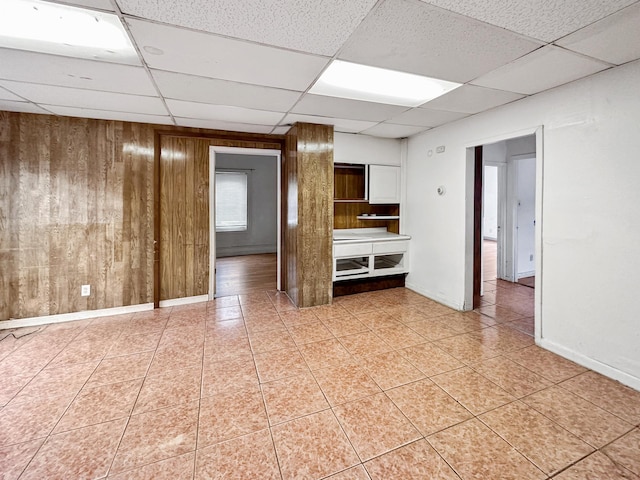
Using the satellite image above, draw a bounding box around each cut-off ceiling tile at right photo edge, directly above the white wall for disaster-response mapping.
[556,2,640,65]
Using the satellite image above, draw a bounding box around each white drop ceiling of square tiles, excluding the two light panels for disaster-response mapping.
[0,0,640,138]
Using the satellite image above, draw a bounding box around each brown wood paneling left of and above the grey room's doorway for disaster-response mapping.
[159,132,282,300]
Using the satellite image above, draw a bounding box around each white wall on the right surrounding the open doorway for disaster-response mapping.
[404,61,640,389]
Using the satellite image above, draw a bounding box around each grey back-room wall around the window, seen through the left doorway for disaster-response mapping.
[216,153,278,257]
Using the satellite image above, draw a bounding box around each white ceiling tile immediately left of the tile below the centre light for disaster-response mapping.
[152,70,301,112]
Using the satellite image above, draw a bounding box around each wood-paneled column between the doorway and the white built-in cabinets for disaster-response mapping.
[283,123,334,307]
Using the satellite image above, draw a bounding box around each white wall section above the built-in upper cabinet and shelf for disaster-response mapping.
[333,132,401,166]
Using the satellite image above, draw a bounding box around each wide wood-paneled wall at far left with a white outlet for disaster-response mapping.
[0,112,154,320]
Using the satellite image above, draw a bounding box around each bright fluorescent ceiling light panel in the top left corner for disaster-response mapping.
[0,0,140,64]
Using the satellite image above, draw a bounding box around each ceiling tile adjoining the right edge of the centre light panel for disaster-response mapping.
[421,85,524,113]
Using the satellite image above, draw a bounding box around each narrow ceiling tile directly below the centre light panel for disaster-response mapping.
[291,94,407,122]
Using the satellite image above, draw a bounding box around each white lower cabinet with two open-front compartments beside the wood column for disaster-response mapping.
[333,241,409,282]
